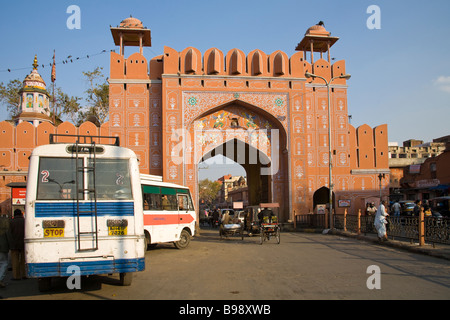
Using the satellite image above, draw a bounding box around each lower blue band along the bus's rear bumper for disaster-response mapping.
[27,258,145,278]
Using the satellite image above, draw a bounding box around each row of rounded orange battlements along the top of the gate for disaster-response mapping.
[110,47,346,84]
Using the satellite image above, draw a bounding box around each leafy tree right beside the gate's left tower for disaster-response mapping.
[82,67,109,124]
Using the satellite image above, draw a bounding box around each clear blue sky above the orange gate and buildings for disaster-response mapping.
[0,0,450,180]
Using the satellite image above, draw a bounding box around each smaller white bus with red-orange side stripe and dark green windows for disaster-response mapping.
[141,174,197,249]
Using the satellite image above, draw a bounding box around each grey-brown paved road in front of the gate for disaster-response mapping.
[0,230,450,301]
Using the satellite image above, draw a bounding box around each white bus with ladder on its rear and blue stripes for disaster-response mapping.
[25,135,145,290]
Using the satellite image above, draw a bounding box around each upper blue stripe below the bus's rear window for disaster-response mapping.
[34,202,134,218]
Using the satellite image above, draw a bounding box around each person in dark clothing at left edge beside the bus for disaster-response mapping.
[8,209,25,280]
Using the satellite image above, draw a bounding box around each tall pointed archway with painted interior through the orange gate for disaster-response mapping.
[186,100,291,221]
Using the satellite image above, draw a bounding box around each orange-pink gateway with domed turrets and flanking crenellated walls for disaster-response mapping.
[0,17,389,221]
